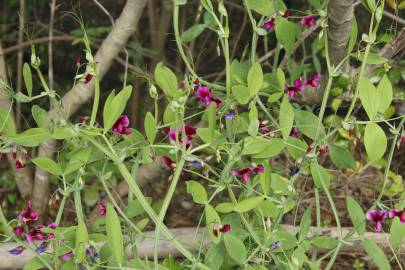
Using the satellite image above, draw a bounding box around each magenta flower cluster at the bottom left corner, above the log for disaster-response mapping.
[9,201,57,255]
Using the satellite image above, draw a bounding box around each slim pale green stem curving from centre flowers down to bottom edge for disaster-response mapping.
[153,158,185,269]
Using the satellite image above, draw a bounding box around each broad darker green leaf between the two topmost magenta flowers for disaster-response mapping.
[275,16,298,54]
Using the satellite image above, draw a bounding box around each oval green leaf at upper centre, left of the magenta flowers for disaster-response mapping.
[155,62,178,98]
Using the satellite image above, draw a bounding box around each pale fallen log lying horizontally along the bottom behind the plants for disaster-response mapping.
[0,225,405,269]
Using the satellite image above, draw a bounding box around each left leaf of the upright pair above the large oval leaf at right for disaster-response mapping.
[359,77,380,120]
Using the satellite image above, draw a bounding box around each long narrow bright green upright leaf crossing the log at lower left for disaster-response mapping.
[105,204,124,265]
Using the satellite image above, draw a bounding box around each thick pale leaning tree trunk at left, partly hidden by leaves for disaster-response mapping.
[33,0,146,214]
